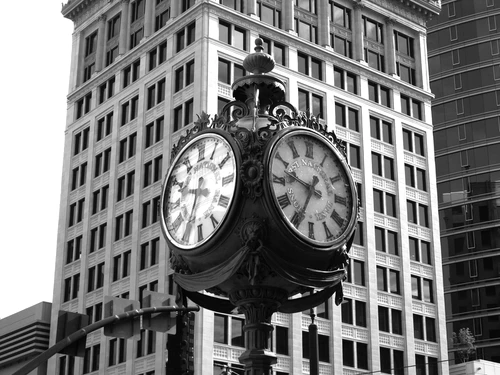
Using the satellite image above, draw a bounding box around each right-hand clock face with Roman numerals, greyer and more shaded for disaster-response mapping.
[269,130,357,246]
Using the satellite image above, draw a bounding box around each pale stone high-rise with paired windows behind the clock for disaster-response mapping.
[49,0,442,375]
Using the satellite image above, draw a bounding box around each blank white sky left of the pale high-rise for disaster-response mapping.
[0,0,73,319]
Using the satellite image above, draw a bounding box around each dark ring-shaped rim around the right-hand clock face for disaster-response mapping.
[264,127,359,250]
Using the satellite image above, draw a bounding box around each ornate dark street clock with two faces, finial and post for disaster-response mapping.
[160,39,359,375]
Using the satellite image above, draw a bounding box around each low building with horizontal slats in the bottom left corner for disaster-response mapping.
[0,302,52,375]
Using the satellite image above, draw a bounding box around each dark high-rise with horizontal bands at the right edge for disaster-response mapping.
[428,0,500,362]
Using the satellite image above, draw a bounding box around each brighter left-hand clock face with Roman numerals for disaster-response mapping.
[162,134,236,249]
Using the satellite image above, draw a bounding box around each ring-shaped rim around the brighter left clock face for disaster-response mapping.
[160,129,241,255]
